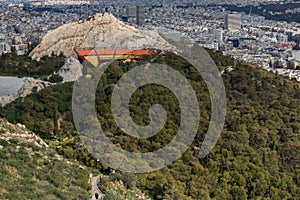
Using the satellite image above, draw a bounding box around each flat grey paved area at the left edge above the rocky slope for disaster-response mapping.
[0,76,24,97]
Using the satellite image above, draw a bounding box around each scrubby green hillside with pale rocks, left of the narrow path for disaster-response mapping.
[0,119,90,200]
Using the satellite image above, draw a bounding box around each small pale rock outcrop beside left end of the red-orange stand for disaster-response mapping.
[58,57,83,82]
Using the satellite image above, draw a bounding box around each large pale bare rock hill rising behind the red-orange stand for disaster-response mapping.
[30,13,175,59]
